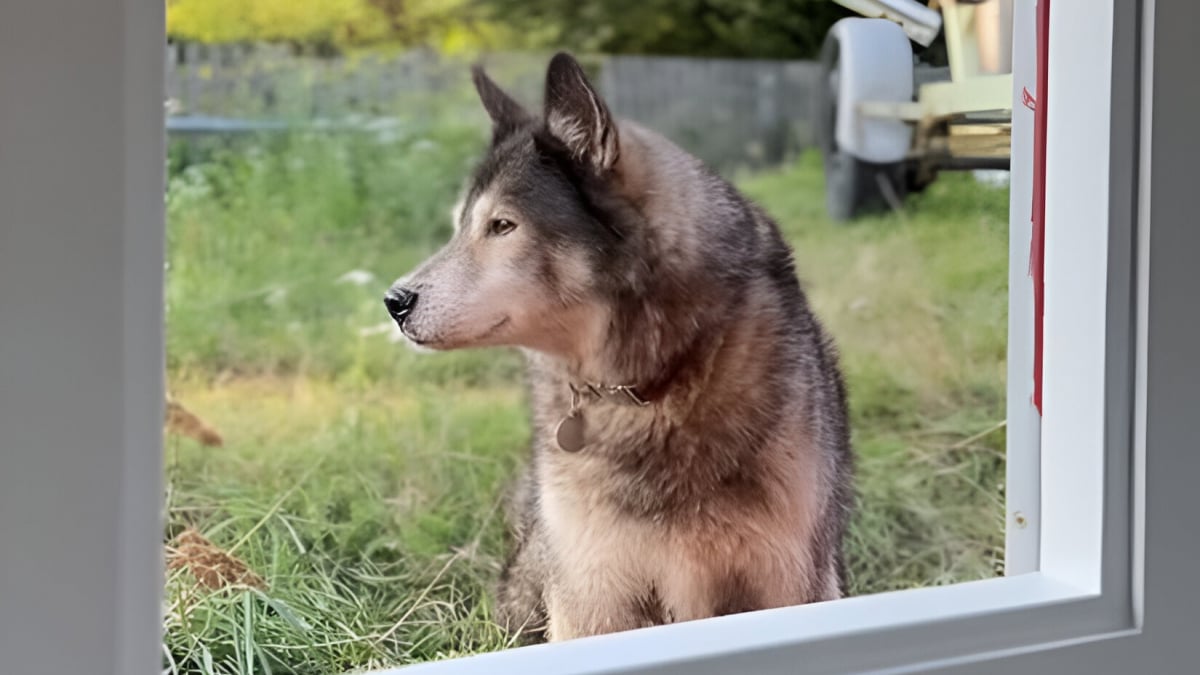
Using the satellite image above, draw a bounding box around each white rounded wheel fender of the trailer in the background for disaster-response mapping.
[829,18,913,163]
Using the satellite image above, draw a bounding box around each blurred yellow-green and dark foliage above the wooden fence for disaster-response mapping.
[167,0,850,59]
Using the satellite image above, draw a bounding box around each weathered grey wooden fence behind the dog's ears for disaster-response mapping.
[166,44,817,167]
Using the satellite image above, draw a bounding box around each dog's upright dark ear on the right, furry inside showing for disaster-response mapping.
[545,52,620,172]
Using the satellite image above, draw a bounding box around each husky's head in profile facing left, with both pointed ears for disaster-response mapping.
[385,54,631,356]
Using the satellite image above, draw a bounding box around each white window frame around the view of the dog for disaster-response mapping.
[7,0,1200,675]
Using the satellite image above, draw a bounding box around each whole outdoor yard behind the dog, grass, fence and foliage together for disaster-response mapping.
[163,0,1008,673]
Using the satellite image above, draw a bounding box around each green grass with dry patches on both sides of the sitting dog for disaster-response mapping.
[164,129,1007,673]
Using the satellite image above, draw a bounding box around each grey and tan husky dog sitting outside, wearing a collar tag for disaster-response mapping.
[385,54,852,641]
